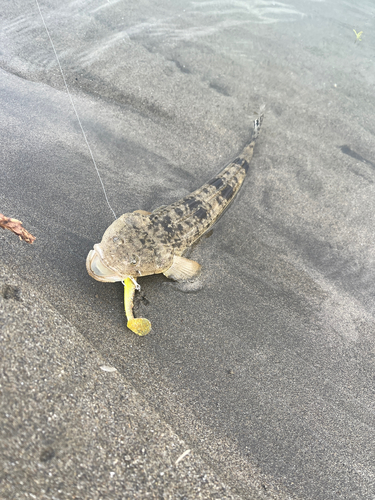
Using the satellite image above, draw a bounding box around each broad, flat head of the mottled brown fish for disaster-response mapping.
[86,213,173,283]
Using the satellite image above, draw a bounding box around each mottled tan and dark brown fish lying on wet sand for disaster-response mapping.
[87,114,263,281]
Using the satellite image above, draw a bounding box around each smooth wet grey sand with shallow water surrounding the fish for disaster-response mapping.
[0,0,375,500]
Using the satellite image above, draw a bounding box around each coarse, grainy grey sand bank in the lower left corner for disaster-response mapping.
[0,269,244,499]
